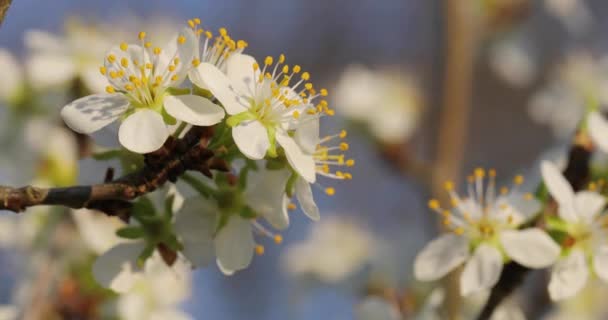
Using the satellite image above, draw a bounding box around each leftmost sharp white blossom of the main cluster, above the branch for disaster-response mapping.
[61,28,224,153]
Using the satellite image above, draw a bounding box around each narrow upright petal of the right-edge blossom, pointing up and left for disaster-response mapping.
[540,161,577,221]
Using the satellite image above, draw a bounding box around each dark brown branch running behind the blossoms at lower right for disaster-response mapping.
[477,132,593,320]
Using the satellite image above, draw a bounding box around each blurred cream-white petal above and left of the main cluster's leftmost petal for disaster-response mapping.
[25,53,76,90]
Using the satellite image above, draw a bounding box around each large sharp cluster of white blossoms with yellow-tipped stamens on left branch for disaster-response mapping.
[50,19,354,292]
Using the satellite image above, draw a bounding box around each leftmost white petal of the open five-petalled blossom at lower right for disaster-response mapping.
[414,233,469,281]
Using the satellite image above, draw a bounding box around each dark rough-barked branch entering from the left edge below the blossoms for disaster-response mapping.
[0,127,228,219]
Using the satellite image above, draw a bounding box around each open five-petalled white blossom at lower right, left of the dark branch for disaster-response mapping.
[414,168,560,296]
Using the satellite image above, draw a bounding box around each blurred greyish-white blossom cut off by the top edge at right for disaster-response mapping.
[545,0,593,34]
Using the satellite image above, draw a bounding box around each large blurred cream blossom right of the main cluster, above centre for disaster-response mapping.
[334,65,422,143]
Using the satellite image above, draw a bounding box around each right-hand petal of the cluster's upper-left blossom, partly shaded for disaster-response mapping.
[164,94,225,126]
